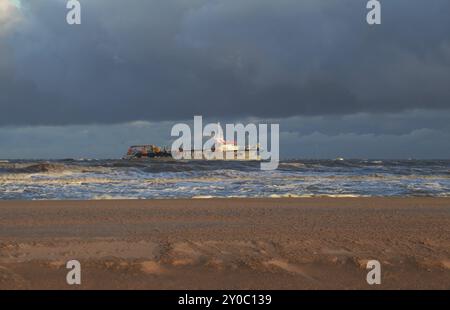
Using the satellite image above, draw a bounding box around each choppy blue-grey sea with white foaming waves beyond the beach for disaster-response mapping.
[0,159,450,200]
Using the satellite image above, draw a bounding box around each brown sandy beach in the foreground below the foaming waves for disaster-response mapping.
[0,198,450,289]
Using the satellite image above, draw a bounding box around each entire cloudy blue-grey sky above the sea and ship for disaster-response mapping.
[0,0,450,158]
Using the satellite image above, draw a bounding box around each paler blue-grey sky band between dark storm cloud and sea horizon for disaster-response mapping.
[0,110,450,159]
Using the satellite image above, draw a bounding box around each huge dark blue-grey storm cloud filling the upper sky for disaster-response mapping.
[0,0,450,125]
